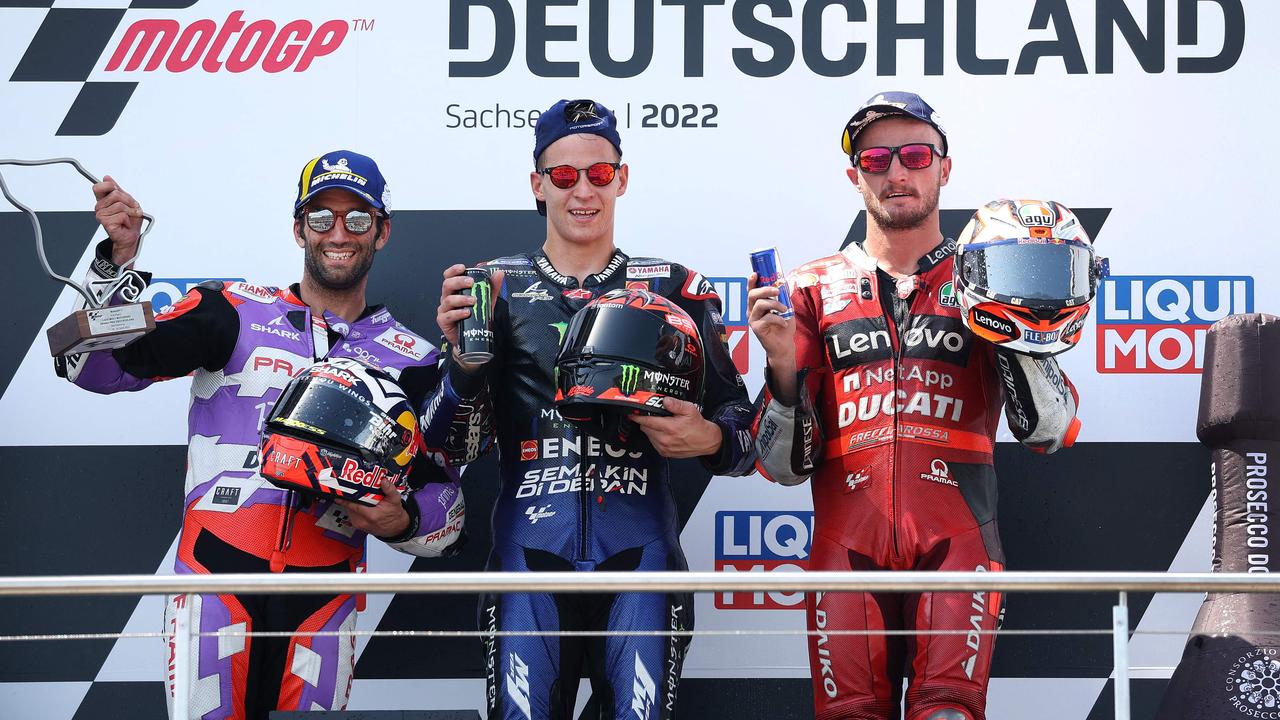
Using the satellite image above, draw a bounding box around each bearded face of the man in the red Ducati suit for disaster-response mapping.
[847,117,951,231]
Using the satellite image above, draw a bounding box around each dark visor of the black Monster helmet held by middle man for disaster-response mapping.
[561,305,703,373]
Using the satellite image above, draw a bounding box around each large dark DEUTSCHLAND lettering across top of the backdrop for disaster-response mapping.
[449,0,1244,78]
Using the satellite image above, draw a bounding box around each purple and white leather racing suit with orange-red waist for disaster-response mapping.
[59,243,465,720]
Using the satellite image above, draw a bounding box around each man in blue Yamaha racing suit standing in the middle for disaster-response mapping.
[424,100,754,720]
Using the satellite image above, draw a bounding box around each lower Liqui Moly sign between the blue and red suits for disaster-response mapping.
[716,510,813,610]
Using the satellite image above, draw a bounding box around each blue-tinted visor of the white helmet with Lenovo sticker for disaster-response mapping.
[960,238,1097,306]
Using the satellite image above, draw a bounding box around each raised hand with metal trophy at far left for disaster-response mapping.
[0,158,155,357]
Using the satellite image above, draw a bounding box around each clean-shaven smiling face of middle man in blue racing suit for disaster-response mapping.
[529,133,627,246]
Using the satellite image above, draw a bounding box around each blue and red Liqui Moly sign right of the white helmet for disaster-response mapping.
[1097,275,1253,373]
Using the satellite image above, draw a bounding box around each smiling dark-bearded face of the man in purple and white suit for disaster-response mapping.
[293,190,390,291]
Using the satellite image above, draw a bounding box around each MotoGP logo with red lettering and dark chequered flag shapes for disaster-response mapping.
[8,0,360,136]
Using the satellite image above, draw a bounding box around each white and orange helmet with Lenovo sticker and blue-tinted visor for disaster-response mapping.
[952,199,1105,356]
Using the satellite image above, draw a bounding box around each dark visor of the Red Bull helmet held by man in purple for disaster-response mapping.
[266,378,411,457]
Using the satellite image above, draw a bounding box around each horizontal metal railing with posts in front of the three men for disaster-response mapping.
[0,571,1280,720]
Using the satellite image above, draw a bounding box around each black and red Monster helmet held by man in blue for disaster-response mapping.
[556,290,703,443]
